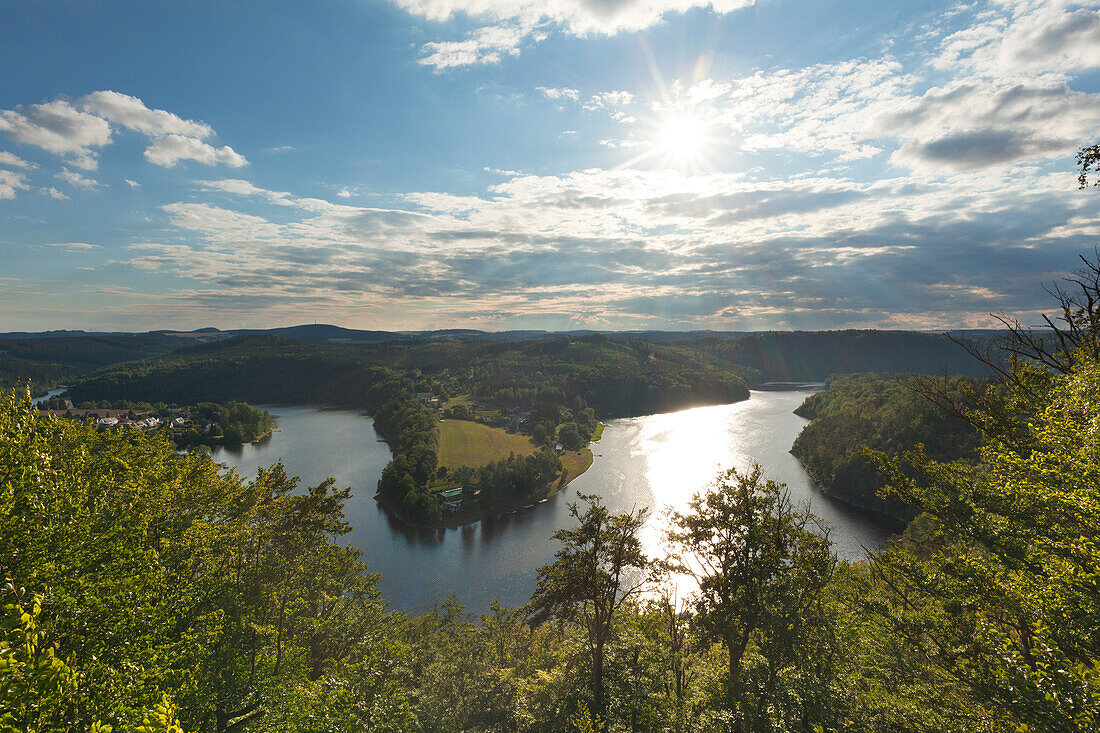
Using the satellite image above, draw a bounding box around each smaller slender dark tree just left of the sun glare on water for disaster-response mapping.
[528,494,649,713]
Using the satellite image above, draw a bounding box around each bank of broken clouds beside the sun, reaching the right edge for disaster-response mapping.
[584,45,1100,174]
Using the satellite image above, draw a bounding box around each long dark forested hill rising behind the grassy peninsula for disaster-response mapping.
[72,335,748,417]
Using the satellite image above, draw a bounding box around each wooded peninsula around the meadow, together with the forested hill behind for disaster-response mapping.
[64,335,748,526]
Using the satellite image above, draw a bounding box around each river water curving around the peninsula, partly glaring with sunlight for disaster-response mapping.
[215,391,888,613]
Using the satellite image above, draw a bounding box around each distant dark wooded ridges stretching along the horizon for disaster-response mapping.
[0,326,985,394]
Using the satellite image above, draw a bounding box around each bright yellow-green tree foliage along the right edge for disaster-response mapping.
[862,352,1100,731]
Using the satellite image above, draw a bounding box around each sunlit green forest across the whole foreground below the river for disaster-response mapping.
[0,259,1100,733]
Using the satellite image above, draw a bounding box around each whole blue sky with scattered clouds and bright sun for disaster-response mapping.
[0,0,1100,331]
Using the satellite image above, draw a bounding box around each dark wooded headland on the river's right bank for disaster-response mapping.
[791,374,988,521]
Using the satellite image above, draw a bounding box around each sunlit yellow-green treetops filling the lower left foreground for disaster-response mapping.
[0,385,408,733]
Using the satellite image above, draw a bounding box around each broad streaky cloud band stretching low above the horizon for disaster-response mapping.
[111,156,1100,328]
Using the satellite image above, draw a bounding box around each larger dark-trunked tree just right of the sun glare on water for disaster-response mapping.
[668,464,835,727]
